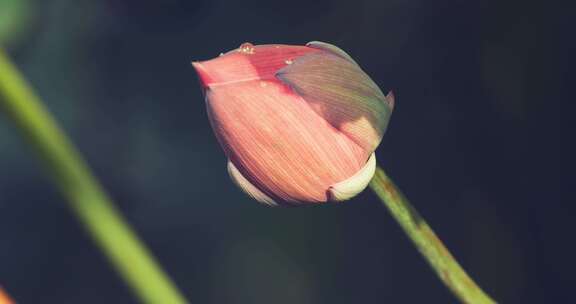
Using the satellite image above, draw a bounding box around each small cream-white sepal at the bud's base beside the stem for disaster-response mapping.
[328,153,376,202]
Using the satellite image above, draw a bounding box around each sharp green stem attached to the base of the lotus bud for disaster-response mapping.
[370,168,496,304]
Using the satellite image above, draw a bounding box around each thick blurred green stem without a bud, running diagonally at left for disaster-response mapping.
[0,48,186,304]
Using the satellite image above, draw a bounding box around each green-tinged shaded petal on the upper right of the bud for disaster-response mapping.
[276,46,392,156]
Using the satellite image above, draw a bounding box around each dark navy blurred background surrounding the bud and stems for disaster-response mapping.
[0,0,576,304]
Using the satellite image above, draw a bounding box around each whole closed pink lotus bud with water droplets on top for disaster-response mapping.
[193,42,394,205]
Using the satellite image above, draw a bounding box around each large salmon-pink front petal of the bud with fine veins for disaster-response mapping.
[206,80,369,202]
